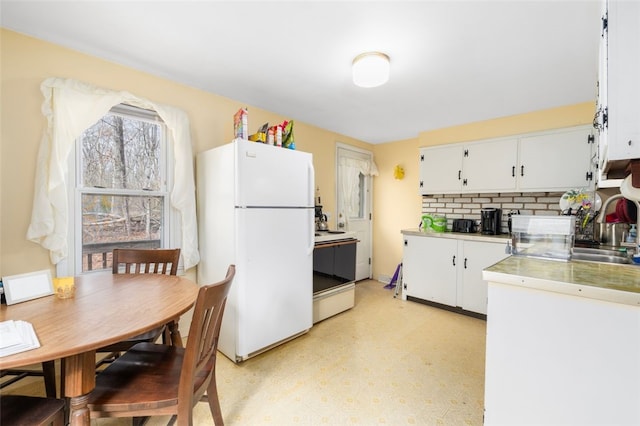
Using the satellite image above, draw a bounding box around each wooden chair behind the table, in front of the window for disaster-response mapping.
[96,248,182,367]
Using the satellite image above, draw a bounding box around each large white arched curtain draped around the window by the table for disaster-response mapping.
[27,78,200,269]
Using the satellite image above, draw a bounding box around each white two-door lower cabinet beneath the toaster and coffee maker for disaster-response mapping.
[402,235,508,314]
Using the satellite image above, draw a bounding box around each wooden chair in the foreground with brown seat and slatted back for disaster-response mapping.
[88,265,235,425]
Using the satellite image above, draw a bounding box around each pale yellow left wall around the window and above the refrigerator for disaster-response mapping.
[0,29,371,276]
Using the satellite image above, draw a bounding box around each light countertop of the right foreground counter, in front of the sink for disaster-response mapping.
[482,256,640,306]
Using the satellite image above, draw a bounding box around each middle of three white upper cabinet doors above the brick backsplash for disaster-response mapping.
[462,138,518,192]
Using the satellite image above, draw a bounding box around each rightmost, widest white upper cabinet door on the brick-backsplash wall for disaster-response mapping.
[516,126,595,191]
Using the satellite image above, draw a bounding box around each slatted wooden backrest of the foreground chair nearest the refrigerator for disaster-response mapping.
[178,265,236,419]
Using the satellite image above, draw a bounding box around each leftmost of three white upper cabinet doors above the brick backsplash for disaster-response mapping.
[420,145,462,194]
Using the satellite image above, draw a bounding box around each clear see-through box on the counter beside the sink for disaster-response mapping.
[511,215,576,261]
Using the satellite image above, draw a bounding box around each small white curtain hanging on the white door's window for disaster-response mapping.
[338,157,378,229]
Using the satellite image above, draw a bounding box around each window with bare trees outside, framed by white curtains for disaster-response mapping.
[70,104,169,273]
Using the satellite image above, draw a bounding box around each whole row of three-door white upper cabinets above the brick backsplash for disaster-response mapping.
[420,126,596,195]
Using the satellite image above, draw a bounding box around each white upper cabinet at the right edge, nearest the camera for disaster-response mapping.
[597,0,640,175]
